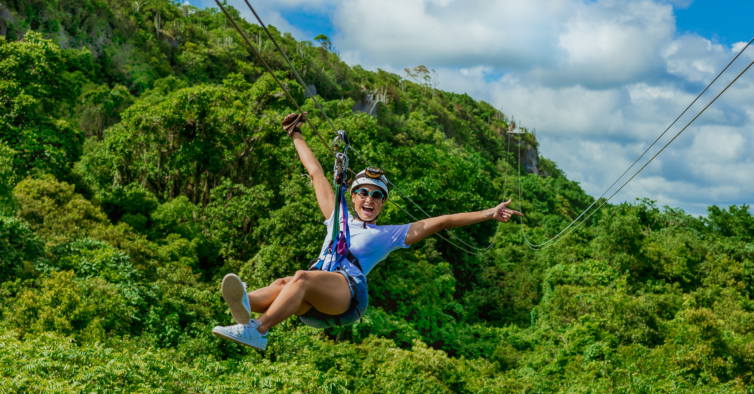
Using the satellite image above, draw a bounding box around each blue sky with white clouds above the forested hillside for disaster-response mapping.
[207,0,754,215]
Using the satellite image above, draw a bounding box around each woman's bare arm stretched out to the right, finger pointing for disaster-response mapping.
[406,200,524,245]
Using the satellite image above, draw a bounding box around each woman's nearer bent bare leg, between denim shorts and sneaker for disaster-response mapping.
[257,271,351,334]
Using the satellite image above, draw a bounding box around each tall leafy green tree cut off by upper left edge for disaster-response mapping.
[0,32,83,177]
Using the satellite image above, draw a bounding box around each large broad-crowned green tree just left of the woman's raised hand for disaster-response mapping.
[102,74,303,205]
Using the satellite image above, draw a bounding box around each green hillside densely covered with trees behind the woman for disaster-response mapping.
[0,0,754,394]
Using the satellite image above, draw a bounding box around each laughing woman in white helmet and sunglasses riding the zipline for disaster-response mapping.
[212,114,524,350]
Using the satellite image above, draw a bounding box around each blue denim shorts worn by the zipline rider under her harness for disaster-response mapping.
[298,269,369,328]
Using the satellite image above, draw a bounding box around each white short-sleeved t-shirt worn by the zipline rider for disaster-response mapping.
[319,210,411,276]
